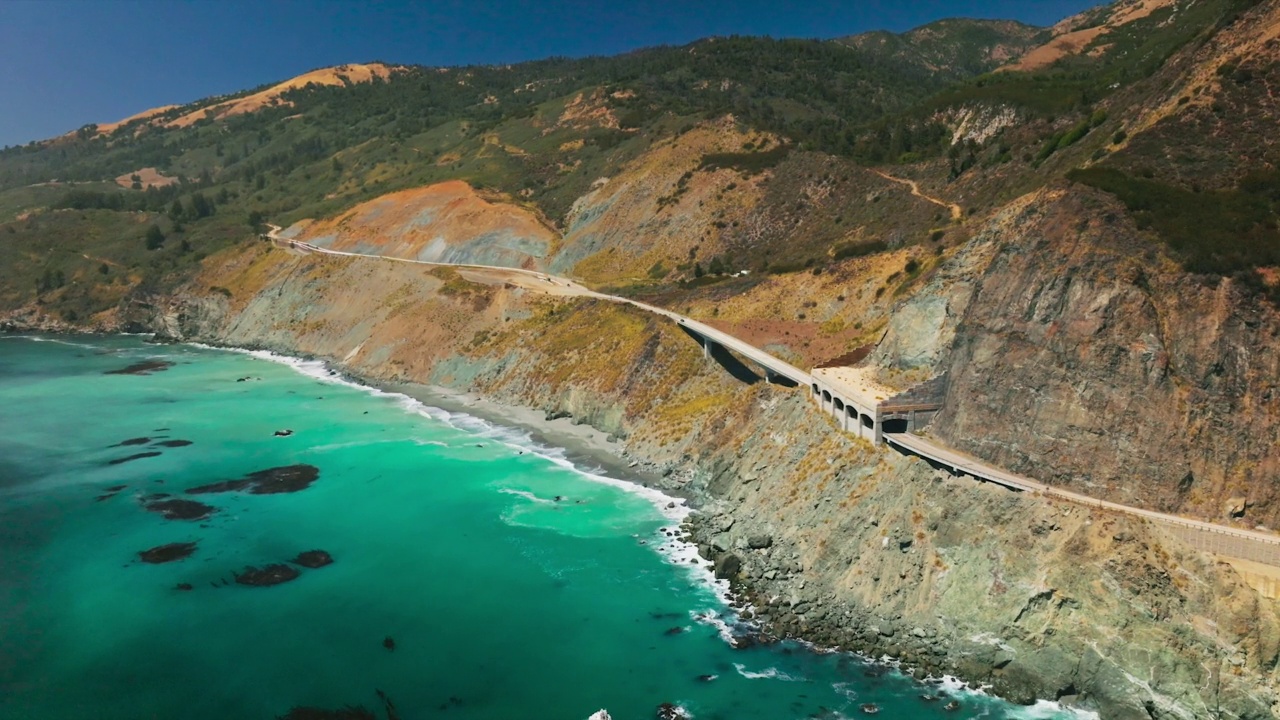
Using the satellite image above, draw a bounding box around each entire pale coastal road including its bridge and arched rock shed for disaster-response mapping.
[264,225,1280,566]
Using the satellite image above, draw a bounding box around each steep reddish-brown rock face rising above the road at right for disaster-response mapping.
[882,188,1280,527]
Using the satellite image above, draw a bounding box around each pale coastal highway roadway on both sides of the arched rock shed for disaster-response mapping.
[265,225,1280,566]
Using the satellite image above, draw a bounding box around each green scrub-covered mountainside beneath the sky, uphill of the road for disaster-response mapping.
[0,0,1268,324]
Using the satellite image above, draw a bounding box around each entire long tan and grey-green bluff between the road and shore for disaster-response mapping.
[35,233,1264,719]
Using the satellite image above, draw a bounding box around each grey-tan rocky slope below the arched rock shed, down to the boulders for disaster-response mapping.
[680,397,1280,720]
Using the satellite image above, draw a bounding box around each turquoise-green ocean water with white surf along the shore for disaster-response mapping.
[0,336,1090,720]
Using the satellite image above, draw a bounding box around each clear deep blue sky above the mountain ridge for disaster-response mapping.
[0,0,1098,146]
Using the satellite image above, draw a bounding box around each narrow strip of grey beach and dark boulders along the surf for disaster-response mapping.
[183,338,1088,710]
